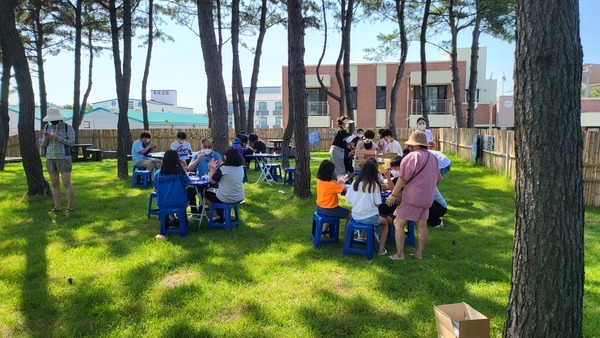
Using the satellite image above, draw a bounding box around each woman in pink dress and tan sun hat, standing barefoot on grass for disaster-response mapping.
[386,130,442,260]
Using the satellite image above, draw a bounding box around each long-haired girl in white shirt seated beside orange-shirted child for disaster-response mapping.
[346,160,388,255]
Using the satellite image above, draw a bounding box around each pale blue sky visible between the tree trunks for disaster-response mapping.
[11,0,600,113]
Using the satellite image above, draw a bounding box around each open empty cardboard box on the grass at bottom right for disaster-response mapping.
[433,303,490,338]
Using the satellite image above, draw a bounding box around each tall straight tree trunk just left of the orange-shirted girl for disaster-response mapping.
[287,0,310,197]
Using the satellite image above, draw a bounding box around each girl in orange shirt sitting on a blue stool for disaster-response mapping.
[317,160,352,233]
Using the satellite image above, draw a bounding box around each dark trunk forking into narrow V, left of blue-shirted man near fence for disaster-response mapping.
[109,0,132,178]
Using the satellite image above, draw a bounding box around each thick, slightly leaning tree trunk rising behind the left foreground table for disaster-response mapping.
[196,0,227,153]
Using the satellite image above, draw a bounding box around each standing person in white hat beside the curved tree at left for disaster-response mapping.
[42,107,75,212]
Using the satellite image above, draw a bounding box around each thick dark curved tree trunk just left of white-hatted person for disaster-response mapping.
[0,0,51,196]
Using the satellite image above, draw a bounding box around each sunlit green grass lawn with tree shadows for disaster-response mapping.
[0,153,600,337]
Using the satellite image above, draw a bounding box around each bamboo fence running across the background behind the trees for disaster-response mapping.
[6,128,600,206]
